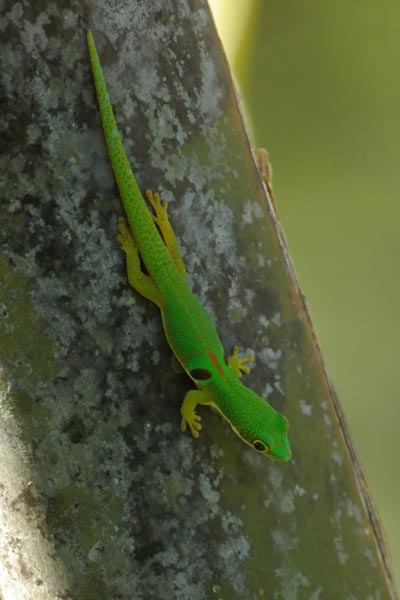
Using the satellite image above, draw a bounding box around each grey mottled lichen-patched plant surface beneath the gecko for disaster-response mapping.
[0,0,395,600]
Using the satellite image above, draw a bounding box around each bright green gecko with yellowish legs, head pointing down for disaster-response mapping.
[87,30,291,461]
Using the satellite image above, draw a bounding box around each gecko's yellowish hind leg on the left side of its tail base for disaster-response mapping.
[117,217,162,306]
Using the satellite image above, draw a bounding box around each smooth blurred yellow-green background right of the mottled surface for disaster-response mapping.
[210,0,400,582]
